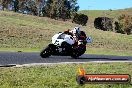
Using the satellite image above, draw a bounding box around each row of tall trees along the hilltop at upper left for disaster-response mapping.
[1,0,79,20]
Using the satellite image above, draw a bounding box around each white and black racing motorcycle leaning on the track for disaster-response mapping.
[40,31,92,58]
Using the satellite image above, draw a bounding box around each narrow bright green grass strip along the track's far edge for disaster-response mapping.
[0,48,132,56]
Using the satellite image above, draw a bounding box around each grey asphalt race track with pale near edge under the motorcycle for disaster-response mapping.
[0,52,132,67]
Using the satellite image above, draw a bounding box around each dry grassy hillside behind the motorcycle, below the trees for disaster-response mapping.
[0,10,132,56]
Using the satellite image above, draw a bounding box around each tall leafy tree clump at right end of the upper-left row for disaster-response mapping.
[43,0,79,20]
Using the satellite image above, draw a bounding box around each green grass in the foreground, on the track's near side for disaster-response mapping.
[0,63,132,88]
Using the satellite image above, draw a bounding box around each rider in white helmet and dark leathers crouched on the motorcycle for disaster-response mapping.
[64,27,87,54]
